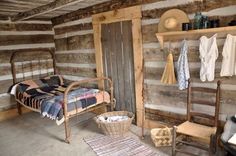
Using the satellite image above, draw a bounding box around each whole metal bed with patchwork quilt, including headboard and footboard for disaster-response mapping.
[11,51,114,143]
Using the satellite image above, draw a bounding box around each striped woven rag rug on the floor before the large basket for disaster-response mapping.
[84,135,167,156]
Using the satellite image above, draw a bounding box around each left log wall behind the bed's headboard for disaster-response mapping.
[0,21,55,111]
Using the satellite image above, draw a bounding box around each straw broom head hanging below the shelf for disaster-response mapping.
[161,53,176,84]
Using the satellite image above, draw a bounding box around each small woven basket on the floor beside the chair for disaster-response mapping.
[151,126,172,147]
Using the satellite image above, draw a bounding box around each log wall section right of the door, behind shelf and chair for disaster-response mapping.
[142,0,236,124]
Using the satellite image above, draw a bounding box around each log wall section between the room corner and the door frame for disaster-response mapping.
[54,17,96,80]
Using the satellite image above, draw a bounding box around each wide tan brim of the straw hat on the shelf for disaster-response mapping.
[158,9,189,32]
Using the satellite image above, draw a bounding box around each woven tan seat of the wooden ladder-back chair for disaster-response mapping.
[176,121,217,143]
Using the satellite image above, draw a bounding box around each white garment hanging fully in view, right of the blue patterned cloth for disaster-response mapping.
[199,34,218,81]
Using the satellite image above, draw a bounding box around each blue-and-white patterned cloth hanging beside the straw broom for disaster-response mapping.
[177,40,190,90]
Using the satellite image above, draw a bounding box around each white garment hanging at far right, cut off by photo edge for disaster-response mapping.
[220,34,236,76]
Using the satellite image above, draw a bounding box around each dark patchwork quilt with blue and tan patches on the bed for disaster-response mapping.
[13,75,110,120]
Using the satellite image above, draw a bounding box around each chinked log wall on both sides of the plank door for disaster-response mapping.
[52,0,236,124]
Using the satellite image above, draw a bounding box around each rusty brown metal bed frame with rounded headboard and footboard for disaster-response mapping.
[10,51,114,143]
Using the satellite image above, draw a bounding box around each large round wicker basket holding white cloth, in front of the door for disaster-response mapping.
[95,111,134,136]
